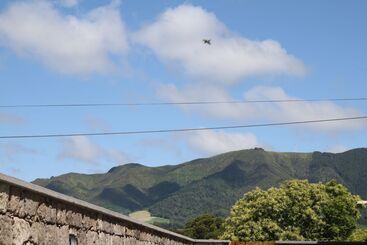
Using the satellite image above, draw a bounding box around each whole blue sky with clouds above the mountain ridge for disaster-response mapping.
[0,0,367,181]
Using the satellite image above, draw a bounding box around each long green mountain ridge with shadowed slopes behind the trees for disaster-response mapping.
[34,148,367,227]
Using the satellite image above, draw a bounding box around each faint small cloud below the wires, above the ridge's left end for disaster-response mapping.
[58,136,128,165]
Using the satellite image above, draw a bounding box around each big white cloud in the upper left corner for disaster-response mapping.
[0,0,128,74]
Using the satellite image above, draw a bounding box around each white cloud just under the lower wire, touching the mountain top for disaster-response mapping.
[185,131,260,155]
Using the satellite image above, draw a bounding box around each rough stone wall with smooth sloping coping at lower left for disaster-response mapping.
[0,174,228,245]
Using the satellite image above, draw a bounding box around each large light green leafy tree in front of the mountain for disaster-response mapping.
[222,180,360,241]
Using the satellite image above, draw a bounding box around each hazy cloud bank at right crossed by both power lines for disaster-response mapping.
[158,84,363,132]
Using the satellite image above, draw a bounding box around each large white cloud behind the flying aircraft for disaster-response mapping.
[134,4,305,84]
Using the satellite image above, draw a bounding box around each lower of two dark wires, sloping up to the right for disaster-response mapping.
[0,116,367,139]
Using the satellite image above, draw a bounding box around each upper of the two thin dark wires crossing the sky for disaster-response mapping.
[0,97,367,108]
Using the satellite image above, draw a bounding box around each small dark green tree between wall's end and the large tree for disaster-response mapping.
[183,214,224,239]
